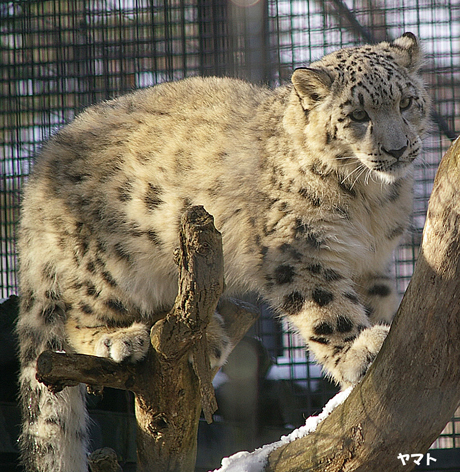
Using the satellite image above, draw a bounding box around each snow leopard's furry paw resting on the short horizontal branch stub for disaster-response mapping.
[95,323,150,362]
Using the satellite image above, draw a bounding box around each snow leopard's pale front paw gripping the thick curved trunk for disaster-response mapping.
[332,325,390,389]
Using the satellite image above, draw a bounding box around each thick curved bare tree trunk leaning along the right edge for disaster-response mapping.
[265,140,460,472]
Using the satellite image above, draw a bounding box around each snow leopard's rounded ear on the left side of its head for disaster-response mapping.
[291,67,333,109]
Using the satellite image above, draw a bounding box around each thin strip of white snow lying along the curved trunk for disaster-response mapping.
[214,387,352,472]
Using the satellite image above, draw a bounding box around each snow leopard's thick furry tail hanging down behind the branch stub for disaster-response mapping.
[17,291,88,472]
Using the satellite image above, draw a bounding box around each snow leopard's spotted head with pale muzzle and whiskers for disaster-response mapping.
[291,33,429,182]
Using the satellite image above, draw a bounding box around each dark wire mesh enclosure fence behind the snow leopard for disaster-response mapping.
[0,0,460,470]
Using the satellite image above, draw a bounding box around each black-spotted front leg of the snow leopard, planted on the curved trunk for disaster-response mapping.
[266,260,389,387]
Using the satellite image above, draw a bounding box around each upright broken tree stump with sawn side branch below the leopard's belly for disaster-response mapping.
[37,207,257,472]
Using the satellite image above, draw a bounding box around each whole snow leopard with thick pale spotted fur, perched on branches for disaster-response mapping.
[17,33,430,472]
